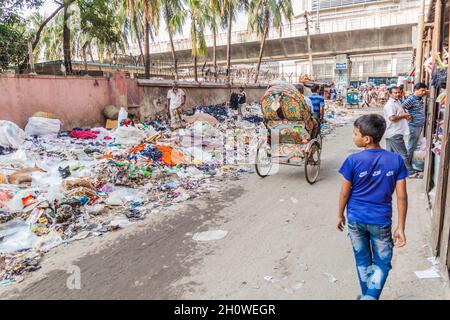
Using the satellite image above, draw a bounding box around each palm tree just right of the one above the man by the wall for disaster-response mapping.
[186,0,209,82]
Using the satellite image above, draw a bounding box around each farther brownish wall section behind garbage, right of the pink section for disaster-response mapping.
[139,80,266,118]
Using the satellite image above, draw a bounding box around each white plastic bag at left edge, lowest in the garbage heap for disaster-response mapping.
[0,219,39,253]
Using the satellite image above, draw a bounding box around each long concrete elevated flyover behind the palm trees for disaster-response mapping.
[151,7,418,67]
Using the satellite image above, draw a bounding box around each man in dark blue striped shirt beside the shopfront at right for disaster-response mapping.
[402,82,427,177]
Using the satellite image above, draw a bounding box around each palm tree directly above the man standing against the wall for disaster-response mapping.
[162,0,187,80]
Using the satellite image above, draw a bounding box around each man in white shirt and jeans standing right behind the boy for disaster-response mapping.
[384,86,414,174]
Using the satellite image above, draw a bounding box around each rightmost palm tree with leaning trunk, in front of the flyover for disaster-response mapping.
[247,0,294,83]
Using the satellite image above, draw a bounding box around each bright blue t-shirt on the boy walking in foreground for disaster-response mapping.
[339,149,408,226]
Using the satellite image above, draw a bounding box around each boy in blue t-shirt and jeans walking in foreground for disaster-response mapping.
[337,114,408,300]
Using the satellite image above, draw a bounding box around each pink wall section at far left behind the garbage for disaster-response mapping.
[0,76,111,129]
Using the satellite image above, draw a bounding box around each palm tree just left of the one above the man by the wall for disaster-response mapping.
[142,0,161,79]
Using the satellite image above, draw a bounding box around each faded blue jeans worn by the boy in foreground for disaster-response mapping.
[348,222,394,300]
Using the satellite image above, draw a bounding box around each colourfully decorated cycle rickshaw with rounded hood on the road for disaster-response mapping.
[255,84,322,184]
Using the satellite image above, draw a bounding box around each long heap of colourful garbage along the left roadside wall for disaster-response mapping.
[0,107,266,286]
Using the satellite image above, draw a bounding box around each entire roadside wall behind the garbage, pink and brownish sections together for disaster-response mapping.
[0,73,266,130]
